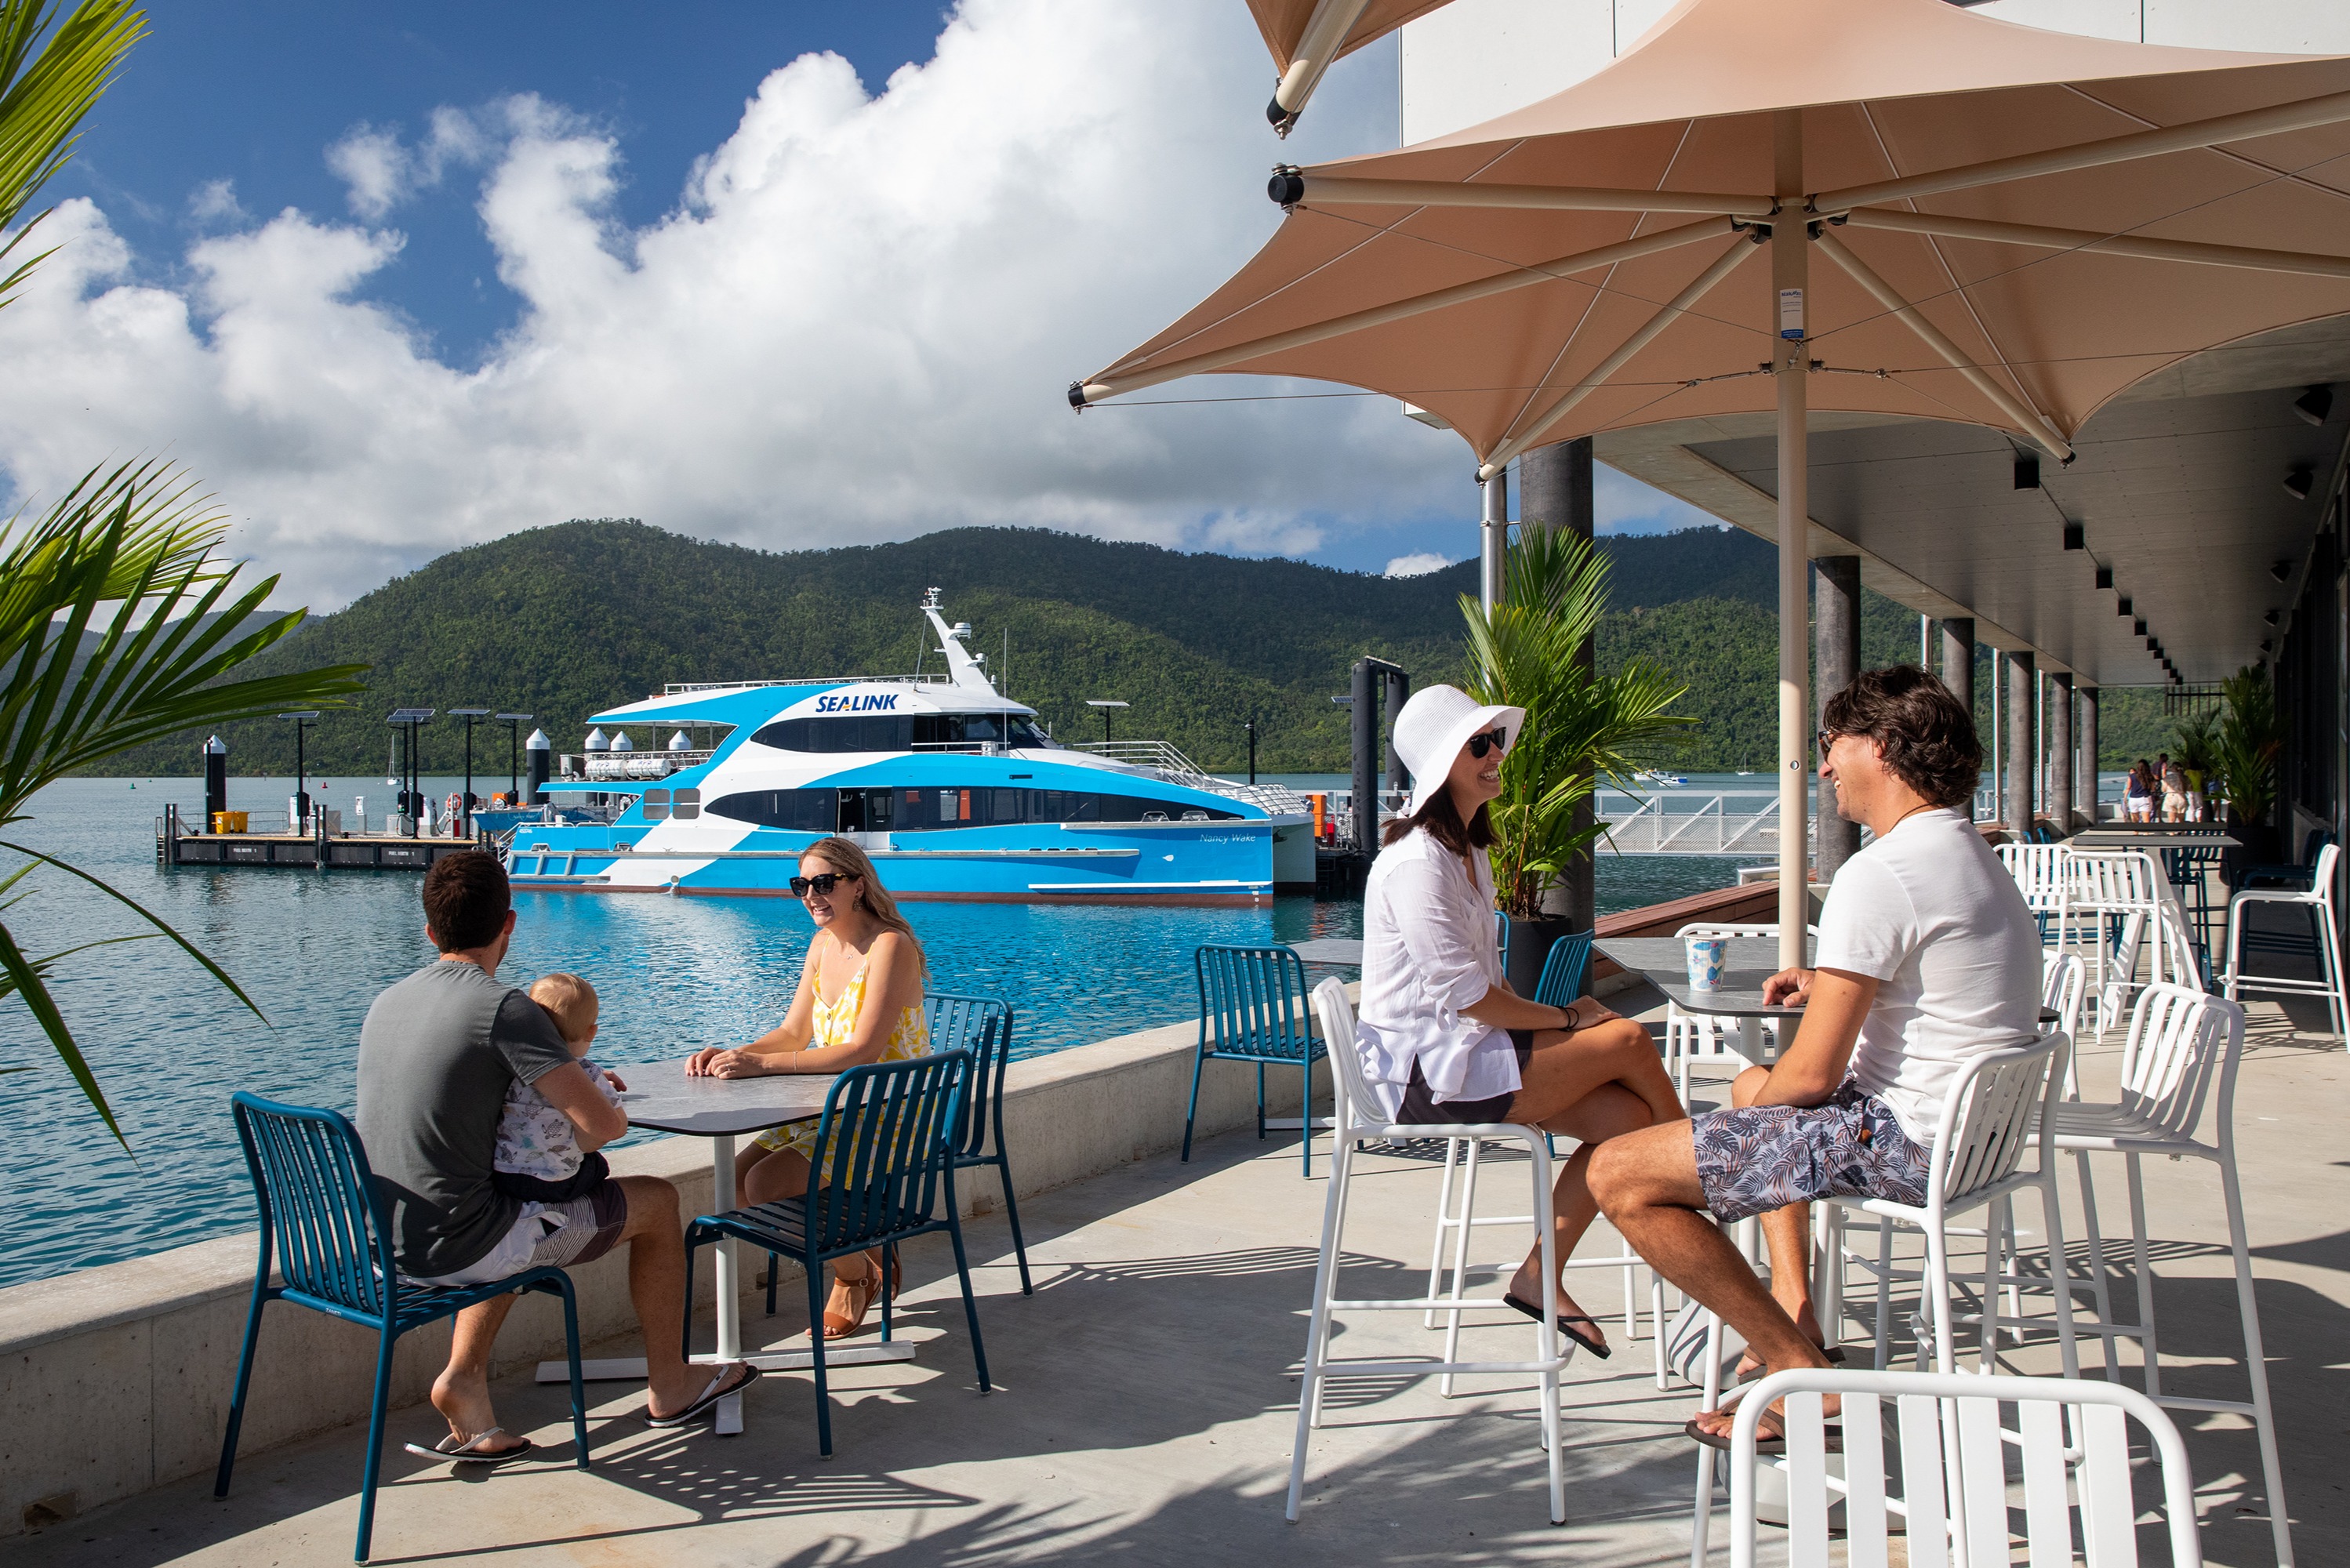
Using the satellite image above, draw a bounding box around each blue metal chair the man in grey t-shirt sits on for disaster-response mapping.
[212,1091,587,1563]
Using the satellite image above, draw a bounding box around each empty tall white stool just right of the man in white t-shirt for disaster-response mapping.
[2051,985,2294,1568]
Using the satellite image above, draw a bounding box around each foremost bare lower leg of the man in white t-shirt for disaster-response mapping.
[1589,1121,1833,1432]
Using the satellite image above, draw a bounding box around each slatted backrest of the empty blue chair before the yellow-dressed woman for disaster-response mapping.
[808,1051,971,1250]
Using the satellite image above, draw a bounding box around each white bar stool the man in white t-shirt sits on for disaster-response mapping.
[1690,1029,2079,1568]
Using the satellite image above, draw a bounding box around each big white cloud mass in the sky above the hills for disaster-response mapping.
[0,0,1473,607]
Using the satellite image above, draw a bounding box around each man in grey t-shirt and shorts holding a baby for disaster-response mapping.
[358,853,759,1462]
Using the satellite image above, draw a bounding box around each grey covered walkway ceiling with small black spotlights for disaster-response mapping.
[1596,318,2350,687]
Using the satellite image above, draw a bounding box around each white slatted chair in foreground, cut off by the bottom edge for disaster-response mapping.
[1709,1370,2202,1568]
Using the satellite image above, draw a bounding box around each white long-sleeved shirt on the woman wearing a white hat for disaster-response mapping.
[1356,829,1518,1121]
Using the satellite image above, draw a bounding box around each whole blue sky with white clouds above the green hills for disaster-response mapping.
[0,0,1702,607]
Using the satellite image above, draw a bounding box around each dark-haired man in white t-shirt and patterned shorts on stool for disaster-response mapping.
[1591,666,2039,1446]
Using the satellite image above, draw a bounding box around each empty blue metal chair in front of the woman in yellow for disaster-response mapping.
[681,1051,990,1460]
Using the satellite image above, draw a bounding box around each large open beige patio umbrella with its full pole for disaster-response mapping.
[1070,0,2350,1006]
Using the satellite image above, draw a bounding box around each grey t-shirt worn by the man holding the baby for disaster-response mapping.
[360,961,571,1279]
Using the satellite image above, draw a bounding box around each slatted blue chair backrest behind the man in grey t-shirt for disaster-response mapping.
[231,1088,392,1316]
